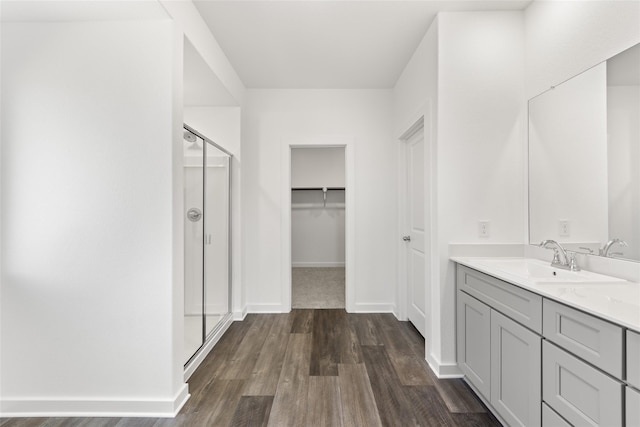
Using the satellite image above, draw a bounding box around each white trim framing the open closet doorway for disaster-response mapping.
[282,136,356,313]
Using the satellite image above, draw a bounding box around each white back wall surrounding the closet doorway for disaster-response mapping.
[242,90,397,311]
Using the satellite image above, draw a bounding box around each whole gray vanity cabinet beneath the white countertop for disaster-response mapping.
[456,264,640,427]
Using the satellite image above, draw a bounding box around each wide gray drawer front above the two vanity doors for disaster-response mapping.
[456,265,542,333]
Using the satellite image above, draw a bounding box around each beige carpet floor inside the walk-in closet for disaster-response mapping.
[291,267,345,308]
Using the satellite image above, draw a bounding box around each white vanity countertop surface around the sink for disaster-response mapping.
[451,257,640,332]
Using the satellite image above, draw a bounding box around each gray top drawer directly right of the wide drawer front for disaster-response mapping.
[542,299,623,379]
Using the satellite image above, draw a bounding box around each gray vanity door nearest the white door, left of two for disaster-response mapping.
[457,291,491,399]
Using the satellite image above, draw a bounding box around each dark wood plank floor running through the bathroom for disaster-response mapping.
[0,310,500,427]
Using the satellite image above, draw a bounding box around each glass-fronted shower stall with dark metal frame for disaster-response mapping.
[183,125,231,367]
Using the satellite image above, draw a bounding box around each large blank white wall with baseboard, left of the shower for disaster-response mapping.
[0,21,186,416]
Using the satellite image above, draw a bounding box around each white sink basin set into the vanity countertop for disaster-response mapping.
[482,258,625,284]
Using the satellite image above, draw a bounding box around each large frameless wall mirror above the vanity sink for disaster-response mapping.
[529,44,640,261]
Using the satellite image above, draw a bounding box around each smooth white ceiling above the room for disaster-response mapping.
[194,0,531,89]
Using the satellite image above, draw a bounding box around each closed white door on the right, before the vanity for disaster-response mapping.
[404,129,426,336]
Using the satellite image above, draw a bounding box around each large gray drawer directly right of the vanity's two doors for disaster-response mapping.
[542,341,623,427]
